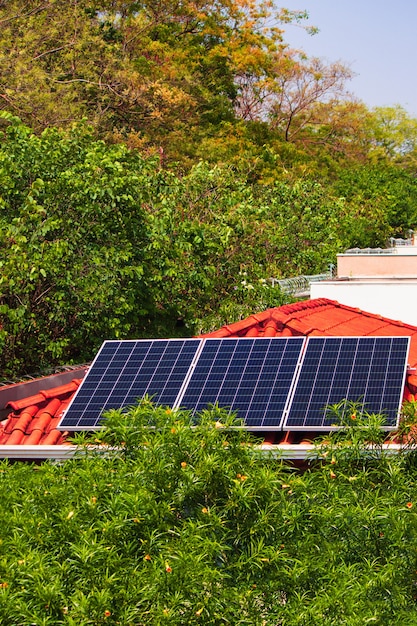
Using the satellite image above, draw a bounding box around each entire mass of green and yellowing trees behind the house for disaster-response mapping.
[0,0,417,379]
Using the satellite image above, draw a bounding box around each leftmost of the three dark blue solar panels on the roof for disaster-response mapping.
[59,339,200,430]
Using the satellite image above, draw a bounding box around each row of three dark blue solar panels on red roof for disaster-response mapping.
[59,337,410,430]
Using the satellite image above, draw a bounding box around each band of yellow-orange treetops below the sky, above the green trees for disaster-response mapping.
[0,0,417,173]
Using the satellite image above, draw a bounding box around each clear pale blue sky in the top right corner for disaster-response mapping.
[276,0,417,117]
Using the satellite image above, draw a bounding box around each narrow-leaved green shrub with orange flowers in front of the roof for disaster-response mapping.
[0,400,417,626]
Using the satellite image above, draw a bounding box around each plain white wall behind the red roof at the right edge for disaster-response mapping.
[310,279,417,326]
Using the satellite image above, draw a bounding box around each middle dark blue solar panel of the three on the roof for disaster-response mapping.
[178,337,305,430]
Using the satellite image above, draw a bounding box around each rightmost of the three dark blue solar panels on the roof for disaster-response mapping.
[284,337,409,430]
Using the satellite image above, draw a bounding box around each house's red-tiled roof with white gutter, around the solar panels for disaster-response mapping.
[0,298,417,459]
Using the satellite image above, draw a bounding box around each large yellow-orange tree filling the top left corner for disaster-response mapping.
[0,0,304,158]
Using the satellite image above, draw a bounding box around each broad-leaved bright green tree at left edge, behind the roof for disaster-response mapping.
[0,117,158,372]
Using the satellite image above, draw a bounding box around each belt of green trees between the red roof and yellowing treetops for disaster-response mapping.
[0,112,417,375]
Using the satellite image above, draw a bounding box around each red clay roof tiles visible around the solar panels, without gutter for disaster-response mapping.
[0,298,417,446]
